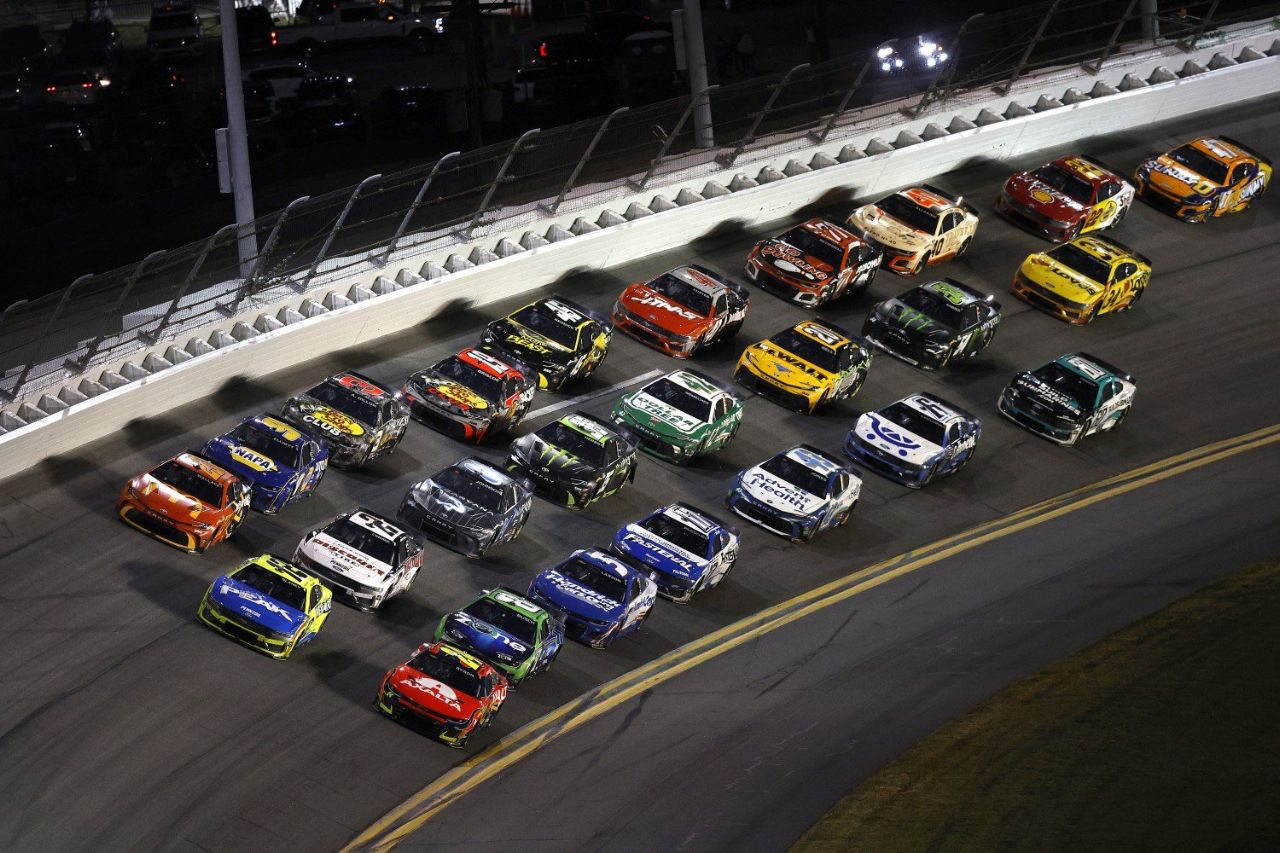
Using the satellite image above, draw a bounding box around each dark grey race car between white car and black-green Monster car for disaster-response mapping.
[398,456,534,557]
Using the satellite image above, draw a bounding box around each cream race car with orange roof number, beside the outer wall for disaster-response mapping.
[849,184,978,275]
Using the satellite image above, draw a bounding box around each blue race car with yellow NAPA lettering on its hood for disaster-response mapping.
[200,415,329,515]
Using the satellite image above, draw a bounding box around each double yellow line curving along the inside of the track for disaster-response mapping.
[343,424,1280,850]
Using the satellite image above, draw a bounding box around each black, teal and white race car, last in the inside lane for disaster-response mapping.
[996,352,1138,444]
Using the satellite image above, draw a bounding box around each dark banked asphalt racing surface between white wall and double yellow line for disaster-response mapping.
[0,97,1280,850]
